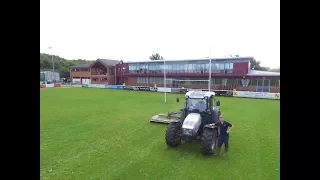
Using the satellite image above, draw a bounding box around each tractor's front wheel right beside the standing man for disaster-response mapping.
[201,128,217,155]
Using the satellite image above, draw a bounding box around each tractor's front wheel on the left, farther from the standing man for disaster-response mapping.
[166,122,182,147]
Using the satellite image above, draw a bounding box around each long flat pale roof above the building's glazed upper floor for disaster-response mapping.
[124,57,255,64]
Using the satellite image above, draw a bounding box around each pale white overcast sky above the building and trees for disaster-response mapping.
[40,0,280,68]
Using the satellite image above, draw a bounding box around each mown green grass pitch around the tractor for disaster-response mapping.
[40,88,280,180]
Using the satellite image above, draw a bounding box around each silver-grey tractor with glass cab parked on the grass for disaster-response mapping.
[165,91,220,155]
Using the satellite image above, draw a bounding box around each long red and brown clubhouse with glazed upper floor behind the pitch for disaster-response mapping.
[70,57,280,92]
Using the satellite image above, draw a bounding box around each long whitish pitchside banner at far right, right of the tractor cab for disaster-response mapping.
[233,91,280,99]
